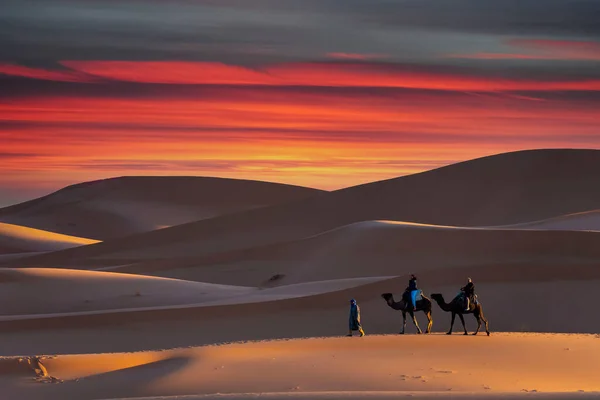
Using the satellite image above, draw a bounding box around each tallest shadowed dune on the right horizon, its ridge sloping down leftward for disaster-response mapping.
[14,150,600,265]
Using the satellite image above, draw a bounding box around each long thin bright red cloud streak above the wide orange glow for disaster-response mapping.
[62,61,600,91]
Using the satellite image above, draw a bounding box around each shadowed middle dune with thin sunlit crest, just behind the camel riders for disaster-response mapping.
[77,221,600,286]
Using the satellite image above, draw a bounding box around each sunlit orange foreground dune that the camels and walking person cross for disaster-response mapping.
[0,334,600,400]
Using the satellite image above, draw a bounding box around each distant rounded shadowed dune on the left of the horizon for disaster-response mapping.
[0,177,321,239]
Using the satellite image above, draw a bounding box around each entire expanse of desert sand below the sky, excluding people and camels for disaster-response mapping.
[0,150,600,400]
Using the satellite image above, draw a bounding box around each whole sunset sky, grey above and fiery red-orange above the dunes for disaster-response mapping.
[0,0,600,206]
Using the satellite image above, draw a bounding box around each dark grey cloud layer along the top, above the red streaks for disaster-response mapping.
[0,0,600,68]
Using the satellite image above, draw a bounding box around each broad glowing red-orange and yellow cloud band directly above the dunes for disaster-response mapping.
[0,87,600,195]
